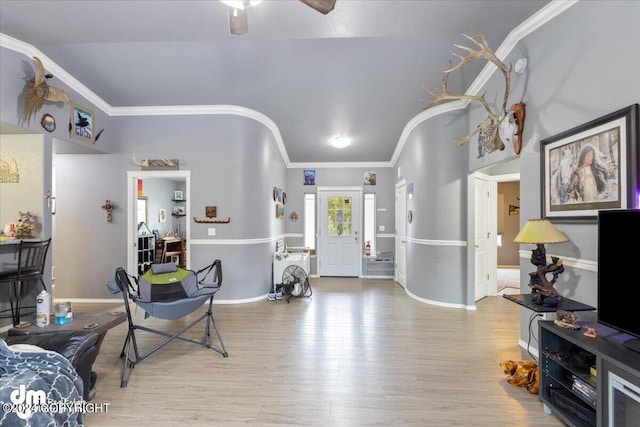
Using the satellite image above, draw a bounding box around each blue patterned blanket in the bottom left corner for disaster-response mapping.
[0,338,85,427]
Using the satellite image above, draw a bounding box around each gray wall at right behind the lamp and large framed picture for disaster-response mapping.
[462,1,640,341]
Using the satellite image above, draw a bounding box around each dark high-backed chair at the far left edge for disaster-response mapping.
[0,238,51,326]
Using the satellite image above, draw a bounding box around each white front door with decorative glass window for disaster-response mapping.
[318,188,362,277]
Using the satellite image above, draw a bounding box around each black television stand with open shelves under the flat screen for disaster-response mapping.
[538,320,640,427]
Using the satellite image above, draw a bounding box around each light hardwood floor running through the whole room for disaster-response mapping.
[79,278,562,427]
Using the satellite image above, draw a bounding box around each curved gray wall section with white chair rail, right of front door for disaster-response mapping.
[397,111,468,305]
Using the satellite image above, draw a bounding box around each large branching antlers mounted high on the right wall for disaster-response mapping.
[423,34,511,150]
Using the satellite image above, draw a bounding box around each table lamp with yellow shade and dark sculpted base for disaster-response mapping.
[513,219,569,306]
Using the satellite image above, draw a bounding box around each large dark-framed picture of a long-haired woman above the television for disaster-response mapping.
[540,104,640,221]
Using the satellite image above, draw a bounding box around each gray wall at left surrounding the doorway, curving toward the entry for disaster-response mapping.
[56,115,285,300]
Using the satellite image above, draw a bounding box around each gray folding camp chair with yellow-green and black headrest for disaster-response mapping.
[107,260,228,387]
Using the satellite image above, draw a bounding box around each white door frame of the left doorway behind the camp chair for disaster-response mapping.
[127,170,191,274]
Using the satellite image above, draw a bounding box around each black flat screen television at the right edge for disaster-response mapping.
[597,209,640,352]
